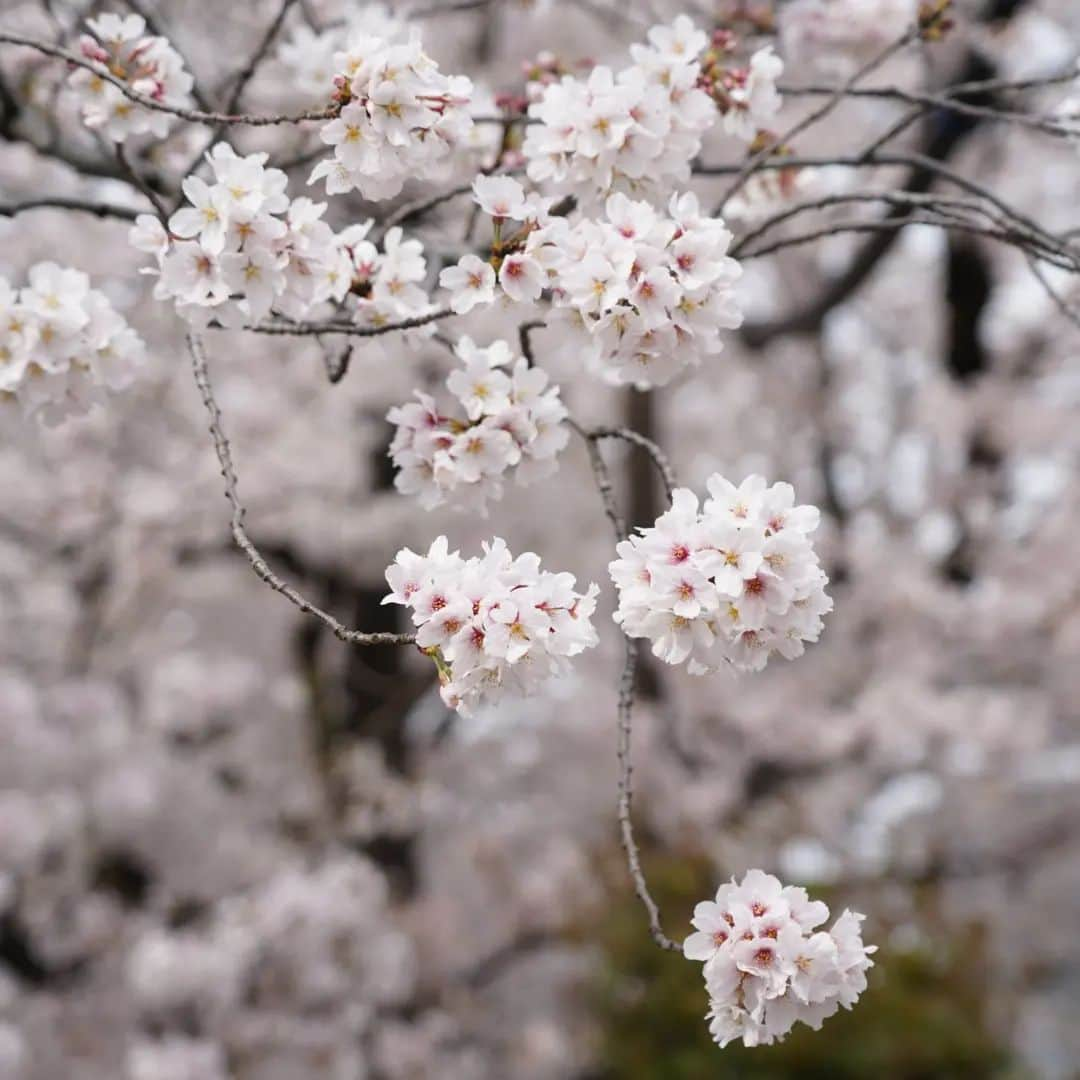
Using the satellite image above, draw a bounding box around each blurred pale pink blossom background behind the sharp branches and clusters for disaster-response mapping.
[0,0,1080,1080]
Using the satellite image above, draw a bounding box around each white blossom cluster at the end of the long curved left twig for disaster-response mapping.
[382,537,598,716]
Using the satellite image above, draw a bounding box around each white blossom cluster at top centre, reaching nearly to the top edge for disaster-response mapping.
[522,15,717,201]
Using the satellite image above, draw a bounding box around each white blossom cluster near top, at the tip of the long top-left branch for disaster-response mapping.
[309,28,473,200]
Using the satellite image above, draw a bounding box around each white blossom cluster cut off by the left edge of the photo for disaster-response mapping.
[0,262,146,423]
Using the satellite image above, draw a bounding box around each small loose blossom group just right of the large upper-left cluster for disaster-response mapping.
[337,219,435,339]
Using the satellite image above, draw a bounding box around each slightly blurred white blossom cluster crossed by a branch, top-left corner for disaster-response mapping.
[69,14,194,143]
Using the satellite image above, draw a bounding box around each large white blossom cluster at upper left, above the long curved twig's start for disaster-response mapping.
[131,143,351,325]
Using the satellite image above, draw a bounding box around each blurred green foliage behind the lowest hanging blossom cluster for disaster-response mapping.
[593,860,1022,1080]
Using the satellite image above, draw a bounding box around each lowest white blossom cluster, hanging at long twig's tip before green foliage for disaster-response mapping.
[683,870,876,1047]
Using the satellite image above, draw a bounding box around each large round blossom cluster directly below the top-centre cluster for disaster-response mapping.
[544,193,742,388]
